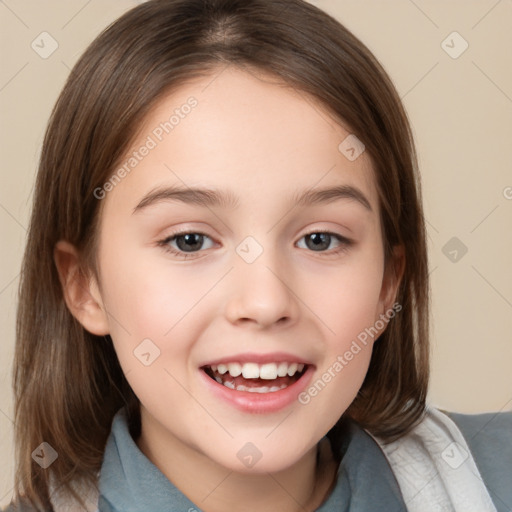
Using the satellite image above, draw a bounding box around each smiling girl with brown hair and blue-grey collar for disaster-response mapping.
[8,0,512,512]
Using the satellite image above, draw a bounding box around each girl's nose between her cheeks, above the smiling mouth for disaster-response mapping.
[226,250,299,328]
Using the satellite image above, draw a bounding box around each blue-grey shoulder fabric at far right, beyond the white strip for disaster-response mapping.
[441,411,512,510]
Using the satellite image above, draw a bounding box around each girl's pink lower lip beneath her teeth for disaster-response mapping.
[199,365,315,414]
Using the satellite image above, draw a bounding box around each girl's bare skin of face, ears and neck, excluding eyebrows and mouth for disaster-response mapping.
[55,66,399,512]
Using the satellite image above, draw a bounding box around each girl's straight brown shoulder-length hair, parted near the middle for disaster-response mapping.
[13,0,429,510]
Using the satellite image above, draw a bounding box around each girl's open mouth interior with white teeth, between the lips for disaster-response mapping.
[201,362,311,393]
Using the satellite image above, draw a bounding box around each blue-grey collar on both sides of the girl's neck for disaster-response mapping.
[98,407,407,512]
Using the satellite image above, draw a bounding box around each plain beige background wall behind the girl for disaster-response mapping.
[0,0,512,505]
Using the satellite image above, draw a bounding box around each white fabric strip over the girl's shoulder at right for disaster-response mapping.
[370,407,496,512]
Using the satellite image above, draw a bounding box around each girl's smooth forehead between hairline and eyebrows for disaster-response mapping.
[104,66,378,216]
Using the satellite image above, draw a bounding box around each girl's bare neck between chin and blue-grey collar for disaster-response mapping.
[136,412,337,512]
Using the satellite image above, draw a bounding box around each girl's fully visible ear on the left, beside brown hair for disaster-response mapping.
[53,240,109,336]
